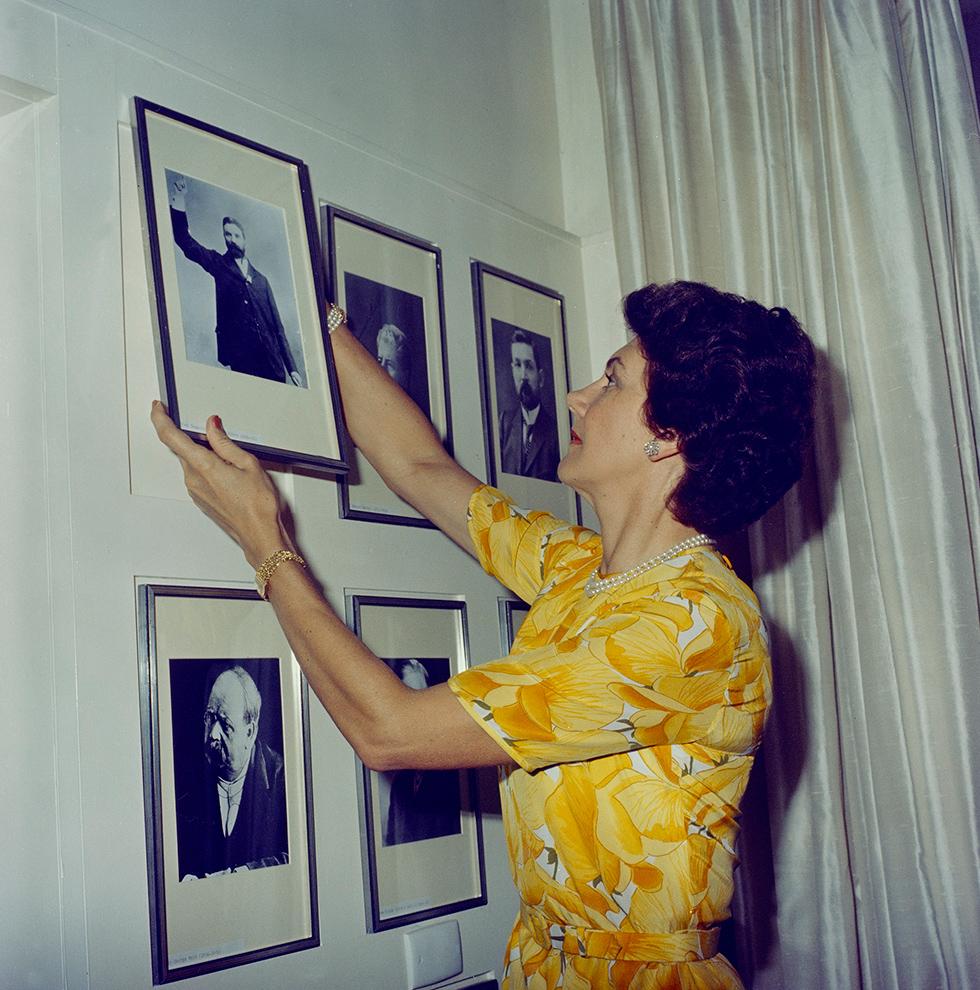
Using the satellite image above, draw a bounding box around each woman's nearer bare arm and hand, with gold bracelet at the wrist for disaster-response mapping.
[151,404,509,770]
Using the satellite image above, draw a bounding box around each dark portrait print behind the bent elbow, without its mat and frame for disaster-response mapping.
[377,657,462,846]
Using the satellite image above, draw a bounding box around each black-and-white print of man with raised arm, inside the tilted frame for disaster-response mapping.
[165,169,307,388]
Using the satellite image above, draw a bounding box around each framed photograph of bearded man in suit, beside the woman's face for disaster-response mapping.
[470,261,582,522]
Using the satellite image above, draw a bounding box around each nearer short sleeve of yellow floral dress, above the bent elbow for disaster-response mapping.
[450,596,767,771]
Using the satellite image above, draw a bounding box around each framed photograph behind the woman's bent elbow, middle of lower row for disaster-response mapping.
[347,593,487,932]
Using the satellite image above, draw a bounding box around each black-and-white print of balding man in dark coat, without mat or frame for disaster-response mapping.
[170,659,289,881]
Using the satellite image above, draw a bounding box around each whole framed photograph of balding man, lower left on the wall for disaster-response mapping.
[137,584,320,984]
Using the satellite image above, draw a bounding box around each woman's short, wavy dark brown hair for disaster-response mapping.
[623,282,814,536]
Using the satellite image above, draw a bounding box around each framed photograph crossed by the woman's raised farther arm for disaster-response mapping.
[320,204,452,527]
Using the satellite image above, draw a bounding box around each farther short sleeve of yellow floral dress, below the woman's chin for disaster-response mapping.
[466,485,596,602]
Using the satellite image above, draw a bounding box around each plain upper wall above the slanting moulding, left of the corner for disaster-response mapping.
[66,0,562,231]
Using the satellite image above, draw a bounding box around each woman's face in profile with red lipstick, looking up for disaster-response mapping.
[558,340,652,502]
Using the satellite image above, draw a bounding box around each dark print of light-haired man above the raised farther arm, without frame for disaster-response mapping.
[344,272,431,416]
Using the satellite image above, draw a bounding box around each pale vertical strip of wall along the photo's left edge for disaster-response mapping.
[0,81,68,987]
